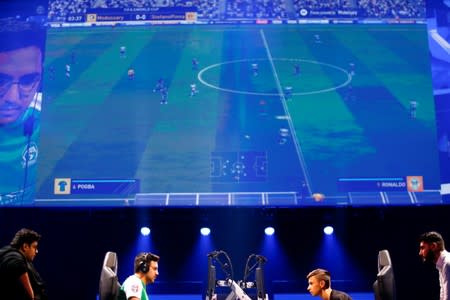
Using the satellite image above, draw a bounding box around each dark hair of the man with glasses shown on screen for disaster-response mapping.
[0,18,46,57]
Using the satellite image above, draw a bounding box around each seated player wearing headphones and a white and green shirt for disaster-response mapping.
[118,252,159,300]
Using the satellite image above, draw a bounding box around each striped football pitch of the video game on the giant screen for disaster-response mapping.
[37,24,440,206]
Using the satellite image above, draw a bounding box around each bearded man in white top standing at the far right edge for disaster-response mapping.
[419,231,450,300]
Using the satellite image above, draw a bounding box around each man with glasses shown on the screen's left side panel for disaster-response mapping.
[0,18,45,206]
